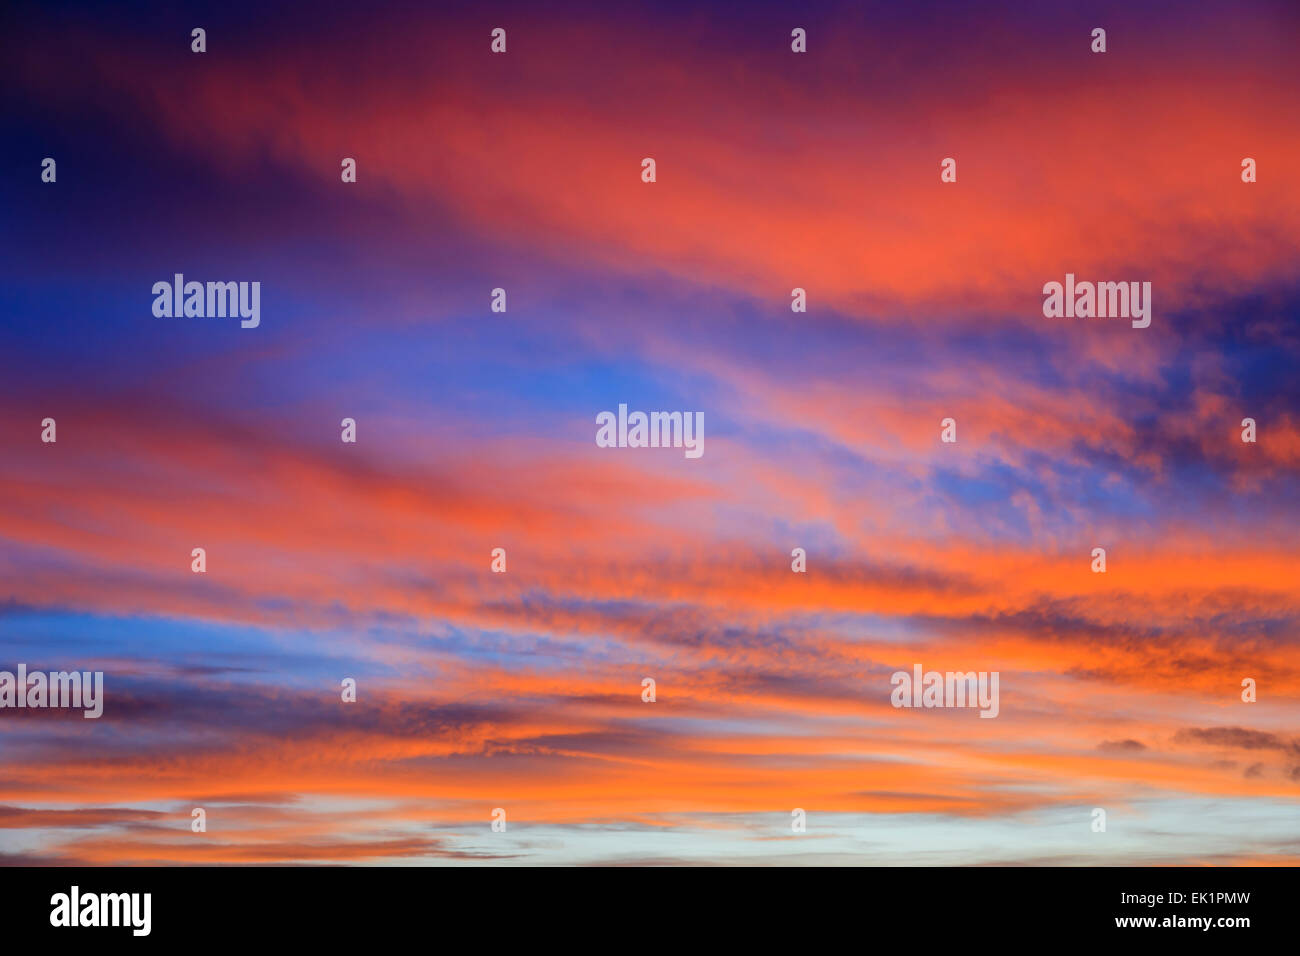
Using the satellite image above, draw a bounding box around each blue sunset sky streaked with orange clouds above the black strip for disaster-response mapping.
[0,0,1300,865]
